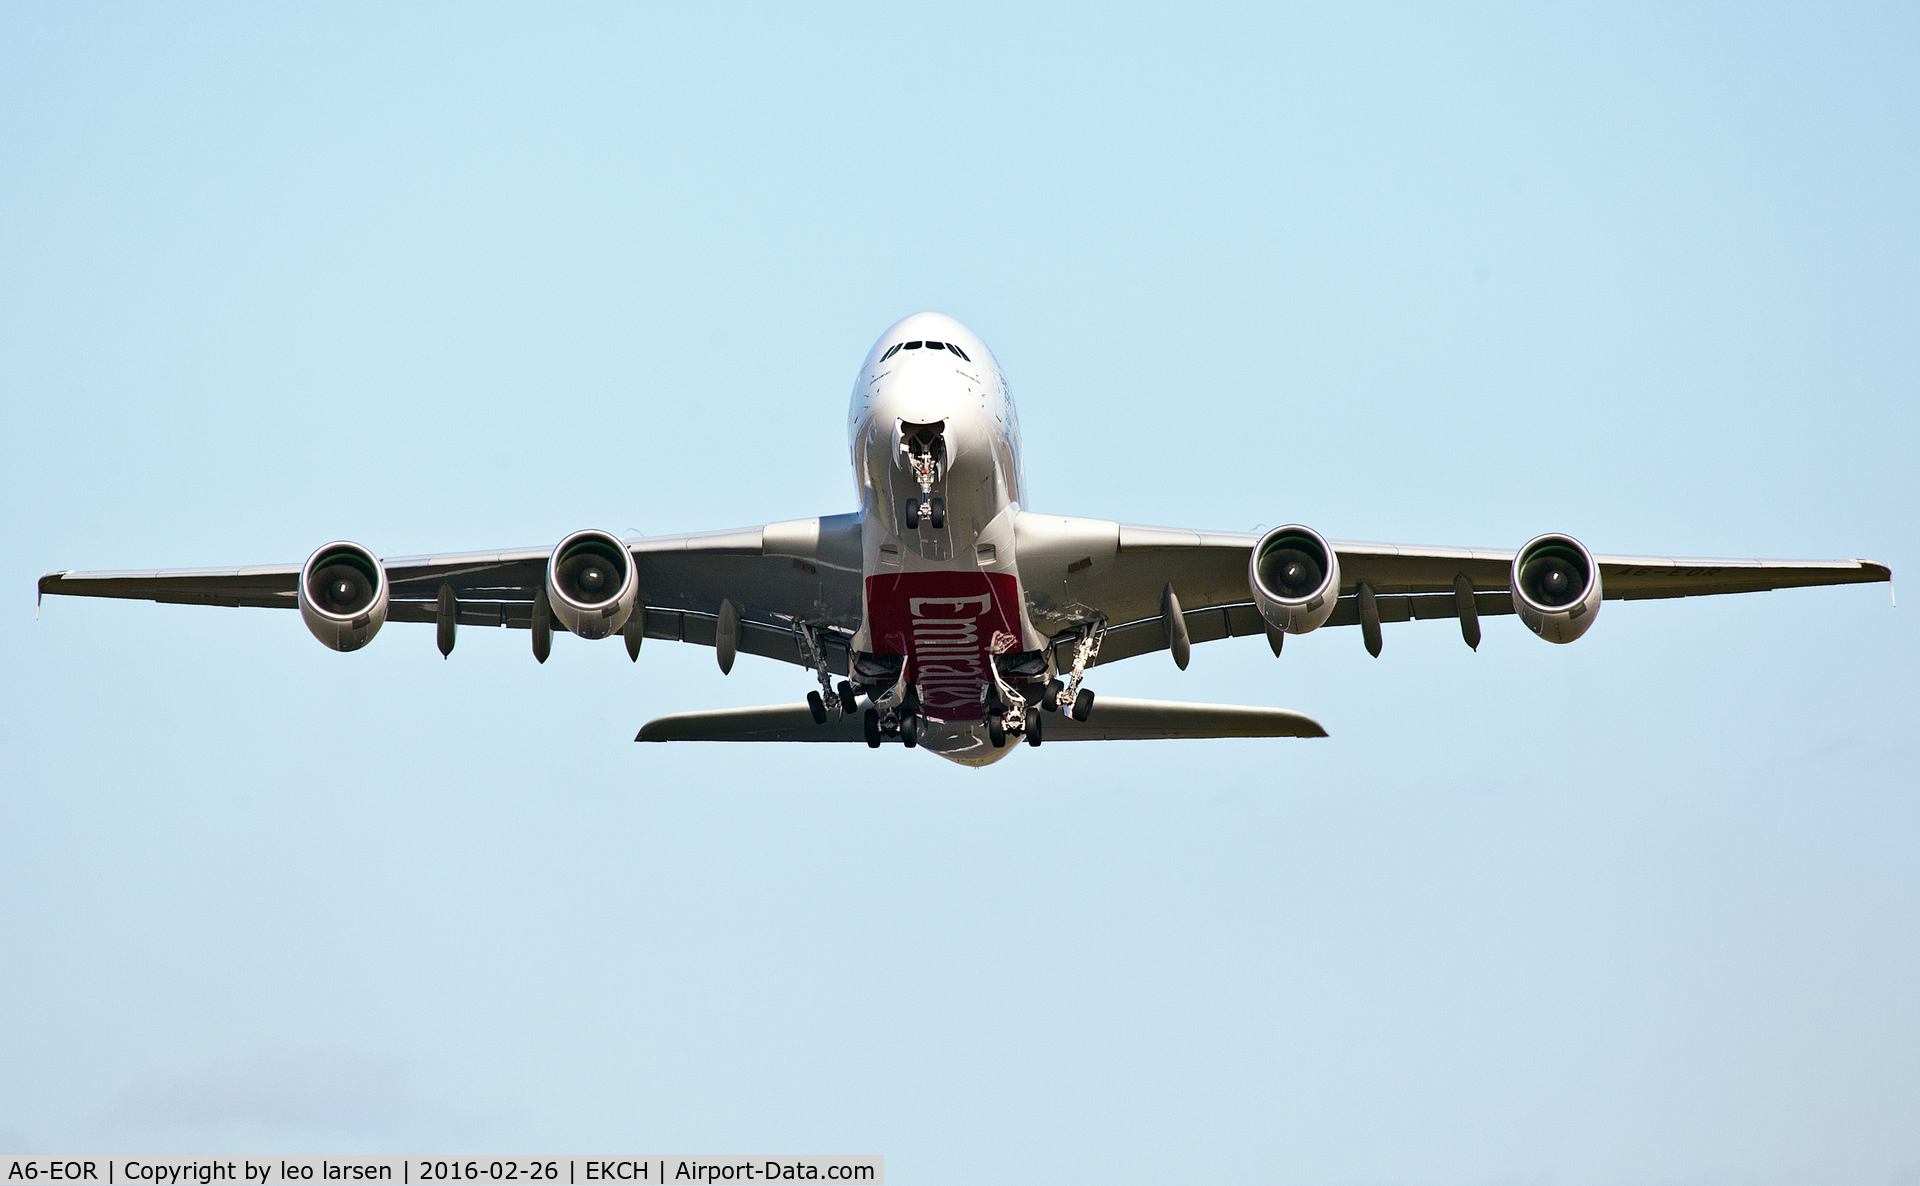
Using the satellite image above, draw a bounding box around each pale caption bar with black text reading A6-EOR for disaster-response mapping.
[0,1155,887,1186]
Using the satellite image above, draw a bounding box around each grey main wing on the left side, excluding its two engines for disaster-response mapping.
[40,514,860,672]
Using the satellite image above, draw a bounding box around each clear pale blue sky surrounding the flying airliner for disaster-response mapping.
[0,4,1920,1186]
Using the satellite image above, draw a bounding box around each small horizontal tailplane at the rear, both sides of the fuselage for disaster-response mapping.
[634,697,1327,743]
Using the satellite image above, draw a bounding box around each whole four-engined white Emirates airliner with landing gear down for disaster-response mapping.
[40,313,1891,766]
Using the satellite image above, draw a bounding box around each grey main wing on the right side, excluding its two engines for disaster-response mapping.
[1014,512,1893,664]
